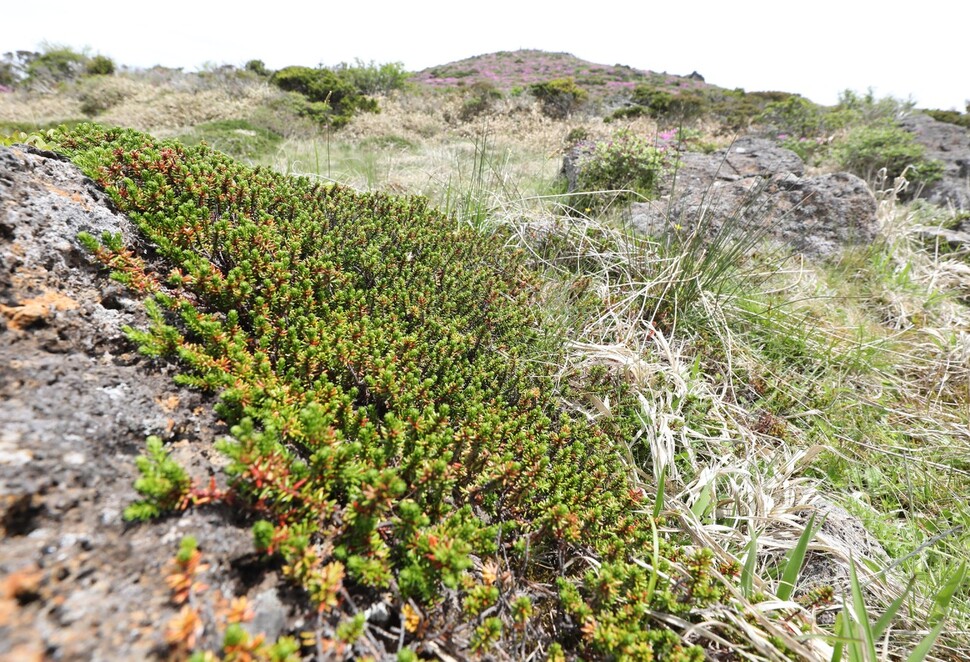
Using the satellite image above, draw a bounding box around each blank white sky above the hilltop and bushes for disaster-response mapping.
[7,0,970,110]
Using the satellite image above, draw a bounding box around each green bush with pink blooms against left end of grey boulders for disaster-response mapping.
[576,130,666,206]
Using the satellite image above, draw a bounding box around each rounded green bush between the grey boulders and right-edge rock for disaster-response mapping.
[832,121,943,185]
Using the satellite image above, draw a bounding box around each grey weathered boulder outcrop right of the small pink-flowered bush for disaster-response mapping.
[631,137,877,258]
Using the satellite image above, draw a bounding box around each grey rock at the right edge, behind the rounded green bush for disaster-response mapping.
[900,114,970,209]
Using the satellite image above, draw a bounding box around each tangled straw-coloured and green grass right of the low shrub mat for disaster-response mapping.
[482,162,970,659]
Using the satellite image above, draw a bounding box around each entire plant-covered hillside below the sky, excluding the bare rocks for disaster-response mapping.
[0,51,970,660]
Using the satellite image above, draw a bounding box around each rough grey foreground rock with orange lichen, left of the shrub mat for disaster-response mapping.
[0,148,288,661]
